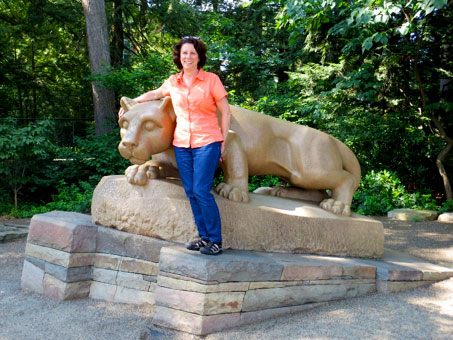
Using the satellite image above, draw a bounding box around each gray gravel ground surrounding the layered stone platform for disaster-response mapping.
[0,218,453,340]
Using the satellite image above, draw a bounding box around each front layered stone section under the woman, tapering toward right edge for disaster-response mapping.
[153,246,453,335]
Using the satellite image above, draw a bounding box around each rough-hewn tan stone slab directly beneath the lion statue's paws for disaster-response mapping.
[91,176,384,258]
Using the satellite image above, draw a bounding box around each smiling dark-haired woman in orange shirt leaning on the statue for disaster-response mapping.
[119,37,231,255]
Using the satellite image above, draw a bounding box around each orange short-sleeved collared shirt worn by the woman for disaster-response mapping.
[162,69,228,148]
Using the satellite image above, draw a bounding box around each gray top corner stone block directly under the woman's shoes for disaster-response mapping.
[159,247,283,282]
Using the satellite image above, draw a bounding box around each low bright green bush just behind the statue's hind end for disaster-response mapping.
[352,170,436,215]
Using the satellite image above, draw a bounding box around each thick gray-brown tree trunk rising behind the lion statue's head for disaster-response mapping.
[82,0,116,134]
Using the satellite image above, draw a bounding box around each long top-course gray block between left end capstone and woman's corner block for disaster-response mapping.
[96,226,174,262]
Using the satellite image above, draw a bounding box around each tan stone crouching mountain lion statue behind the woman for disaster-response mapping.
[118,97,360,216]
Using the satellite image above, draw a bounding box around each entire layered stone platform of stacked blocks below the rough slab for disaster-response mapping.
[22,212,453,335]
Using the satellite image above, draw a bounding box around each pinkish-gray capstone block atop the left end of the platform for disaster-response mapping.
[27,211,97,253]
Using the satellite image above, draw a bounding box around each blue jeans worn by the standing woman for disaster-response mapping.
[174,142,222,243]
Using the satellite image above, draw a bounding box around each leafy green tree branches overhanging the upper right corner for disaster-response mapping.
[280,0,453,199]
